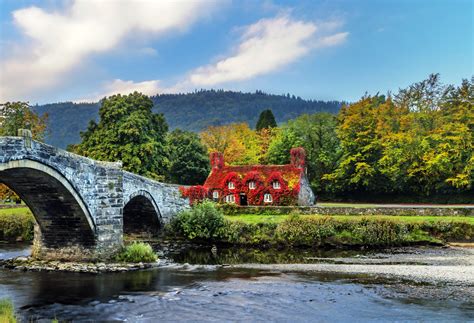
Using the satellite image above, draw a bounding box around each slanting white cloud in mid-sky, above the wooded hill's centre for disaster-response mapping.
[185,16,348,88]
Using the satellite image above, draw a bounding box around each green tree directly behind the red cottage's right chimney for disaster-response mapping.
[268,113,341,192]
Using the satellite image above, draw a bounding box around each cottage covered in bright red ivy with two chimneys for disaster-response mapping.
[202,147,314,206]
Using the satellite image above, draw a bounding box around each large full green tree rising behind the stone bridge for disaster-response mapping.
[72,92,168,180]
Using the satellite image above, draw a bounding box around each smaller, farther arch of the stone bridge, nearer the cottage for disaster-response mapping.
[123,190,163,235]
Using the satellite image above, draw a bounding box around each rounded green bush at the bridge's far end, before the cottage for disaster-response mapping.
[171,201,226,240]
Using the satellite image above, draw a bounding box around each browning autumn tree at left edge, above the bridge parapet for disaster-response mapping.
[0,102,48,141]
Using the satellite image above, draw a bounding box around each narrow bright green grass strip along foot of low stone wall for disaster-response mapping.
[226,214,474,225]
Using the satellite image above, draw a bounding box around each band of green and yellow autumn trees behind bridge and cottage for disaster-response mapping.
[2,74,474,203]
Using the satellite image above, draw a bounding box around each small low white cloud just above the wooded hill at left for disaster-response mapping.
[74,79,163,102]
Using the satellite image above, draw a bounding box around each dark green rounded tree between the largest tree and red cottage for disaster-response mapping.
[168,129,210,185]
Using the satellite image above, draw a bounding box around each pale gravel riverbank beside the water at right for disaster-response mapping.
[230,247,474,284]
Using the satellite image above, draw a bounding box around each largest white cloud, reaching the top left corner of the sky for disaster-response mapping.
[0,0,220,101]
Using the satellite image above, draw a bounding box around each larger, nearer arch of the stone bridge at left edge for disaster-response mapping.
[0,159,96,252]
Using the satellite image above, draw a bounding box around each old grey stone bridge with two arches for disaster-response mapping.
[0,137,188,260]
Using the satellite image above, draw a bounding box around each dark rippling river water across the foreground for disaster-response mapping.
[0,245,474,322]
